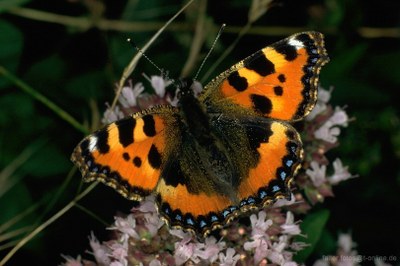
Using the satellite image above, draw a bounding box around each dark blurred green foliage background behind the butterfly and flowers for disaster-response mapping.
[0,0,400,265]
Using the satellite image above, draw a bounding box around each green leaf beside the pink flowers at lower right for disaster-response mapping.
[294,209,330,263]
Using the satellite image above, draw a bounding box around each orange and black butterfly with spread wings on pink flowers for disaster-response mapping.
[71,31,329,236]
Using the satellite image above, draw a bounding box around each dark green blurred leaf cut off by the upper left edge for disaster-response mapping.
[0,20,23,88]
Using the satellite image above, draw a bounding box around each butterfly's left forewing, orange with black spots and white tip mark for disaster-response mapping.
[72,105,178,200]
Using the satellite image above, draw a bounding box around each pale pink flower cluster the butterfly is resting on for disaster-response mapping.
[63,76,353,266]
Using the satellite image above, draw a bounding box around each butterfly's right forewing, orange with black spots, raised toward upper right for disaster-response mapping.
[200,32,328,121]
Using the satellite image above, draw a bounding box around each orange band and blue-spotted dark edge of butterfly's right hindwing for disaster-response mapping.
[239,121,302,208]
